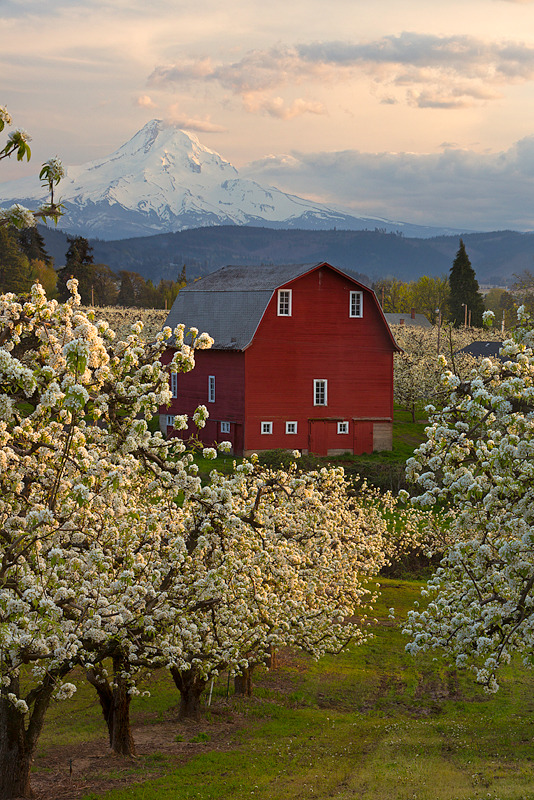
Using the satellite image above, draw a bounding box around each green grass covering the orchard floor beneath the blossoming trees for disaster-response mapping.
[37,580,534,800]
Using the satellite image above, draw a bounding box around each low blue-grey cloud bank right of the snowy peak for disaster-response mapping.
[245,136,534,230]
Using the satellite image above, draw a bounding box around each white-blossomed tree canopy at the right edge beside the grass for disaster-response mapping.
[406,311,534,691]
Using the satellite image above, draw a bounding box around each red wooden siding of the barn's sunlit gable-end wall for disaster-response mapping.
[244,267,393,453]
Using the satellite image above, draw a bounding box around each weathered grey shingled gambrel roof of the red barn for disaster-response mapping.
[165,261,357,350]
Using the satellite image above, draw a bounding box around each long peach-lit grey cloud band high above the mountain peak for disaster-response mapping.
[148,32,534,113]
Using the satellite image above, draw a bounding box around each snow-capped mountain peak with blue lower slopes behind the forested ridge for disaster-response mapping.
[0,120,458,239]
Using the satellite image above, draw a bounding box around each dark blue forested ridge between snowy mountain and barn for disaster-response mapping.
[40,225,534,285]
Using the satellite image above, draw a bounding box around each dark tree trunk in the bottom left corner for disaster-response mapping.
[0,696,32,800]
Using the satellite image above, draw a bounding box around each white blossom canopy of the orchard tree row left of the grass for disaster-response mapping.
[0,280,394,776]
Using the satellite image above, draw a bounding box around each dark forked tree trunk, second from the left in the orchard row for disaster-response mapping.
[86,654,135,756]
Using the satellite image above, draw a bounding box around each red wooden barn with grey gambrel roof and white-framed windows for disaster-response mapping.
[160,262,399,455]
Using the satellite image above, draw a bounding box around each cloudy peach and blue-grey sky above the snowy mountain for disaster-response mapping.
[0,0,534,230]
